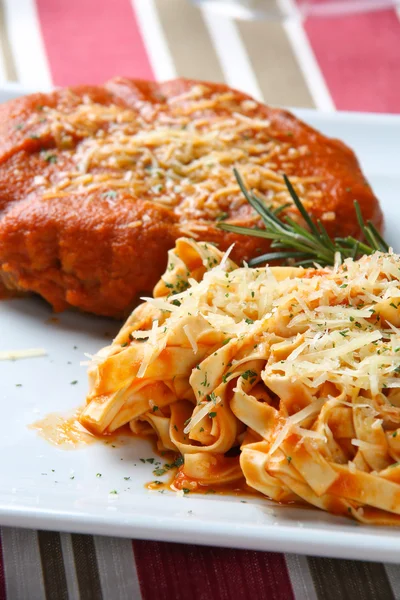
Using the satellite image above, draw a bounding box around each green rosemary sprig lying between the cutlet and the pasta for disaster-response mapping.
[217,169,389,267]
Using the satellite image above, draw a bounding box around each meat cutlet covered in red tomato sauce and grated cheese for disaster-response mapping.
[0,78,382,318]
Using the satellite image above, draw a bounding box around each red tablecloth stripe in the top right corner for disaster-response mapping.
[304,10,400,113]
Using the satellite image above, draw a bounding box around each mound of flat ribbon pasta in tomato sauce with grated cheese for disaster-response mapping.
[80,238,400,525]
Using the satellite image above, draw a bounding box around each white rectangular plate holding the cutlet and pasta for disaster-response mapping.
[0,89,400,562]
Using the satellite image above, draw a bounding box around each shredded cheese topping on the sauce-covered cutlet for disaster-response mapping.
[28,85,321,226]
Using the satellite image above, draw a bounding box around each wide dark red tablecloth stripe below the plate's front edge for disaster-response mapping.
[133,541,294,600]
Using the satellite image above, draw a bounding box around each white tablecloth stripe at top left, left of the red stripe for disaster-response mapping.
[3,0,51,91]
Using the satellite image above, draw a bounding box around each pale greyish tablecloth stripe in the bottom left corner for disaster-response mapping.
[1,527,46,600]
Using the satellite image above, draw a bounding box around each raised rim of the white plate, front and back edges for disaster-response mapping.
[0,83,400,563]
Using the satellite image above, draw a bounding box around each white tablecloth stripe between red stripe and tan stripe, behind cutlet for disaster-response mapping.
[131,0,176,81]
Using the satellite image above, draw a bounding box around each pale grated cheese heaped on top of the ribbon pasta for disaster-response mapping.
[133,242,400,406]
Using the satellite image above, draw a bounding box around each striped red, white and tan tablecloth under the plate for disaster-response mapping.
[0,0,400,600]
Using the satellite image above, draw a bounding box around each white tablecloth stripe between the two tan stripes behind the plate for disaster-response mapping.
[201,6,263,102]
